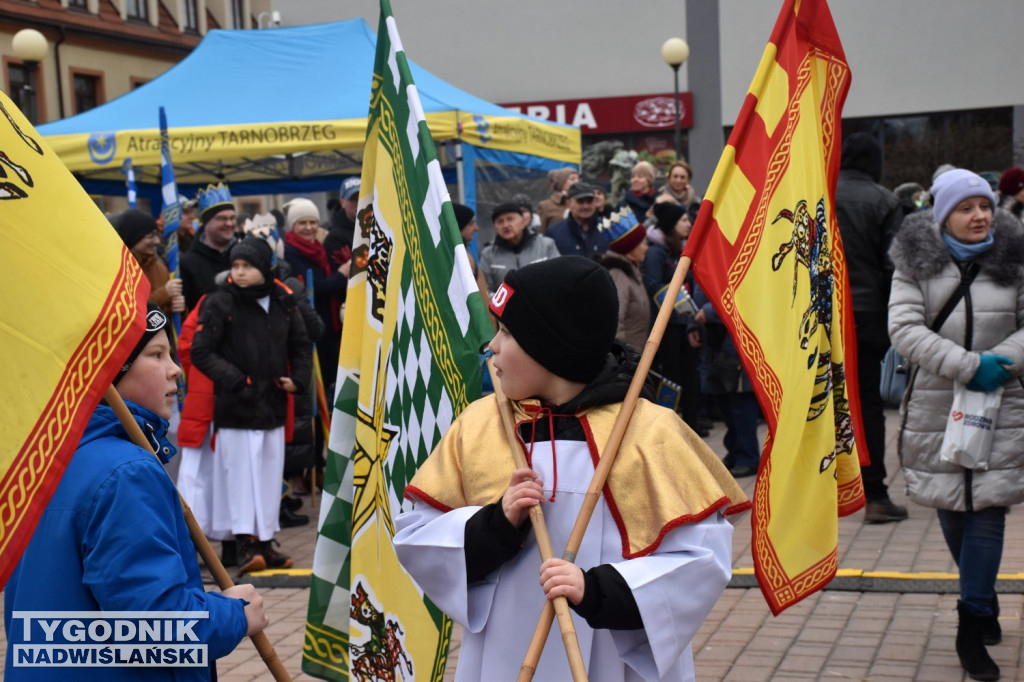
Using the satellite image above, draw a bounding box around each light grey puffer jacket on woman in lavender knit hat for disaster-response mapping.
[889,210,1024,511]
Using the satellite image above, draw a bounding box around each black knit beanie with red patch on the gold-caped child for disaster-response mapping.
[490,256,618,383]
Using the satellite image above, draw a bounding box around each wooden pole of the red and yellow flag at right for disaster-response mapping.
[518,256,691,682]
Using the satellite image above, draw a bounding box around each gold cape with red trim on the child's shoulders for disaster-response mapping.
[406,395,751,559]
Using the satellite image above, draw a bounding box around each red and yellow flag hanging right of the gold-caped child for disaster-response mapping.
[685,0,864,614]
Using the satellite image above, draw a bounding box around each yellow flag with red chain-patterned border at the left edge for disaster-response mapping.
[0,92,150,587]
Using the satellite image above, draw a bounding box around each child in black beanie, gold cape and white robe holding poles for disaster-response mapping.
[394,257,750,682]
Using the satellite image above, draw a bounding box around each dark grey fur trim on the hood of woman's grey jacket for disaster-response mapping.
[889,204,1024,286]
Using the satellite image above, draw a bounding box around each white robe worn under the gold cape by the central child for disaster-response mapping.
[394,440,732,682]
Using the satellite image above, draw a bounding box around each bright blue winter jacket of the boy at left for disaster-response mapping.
[4,402,246,682]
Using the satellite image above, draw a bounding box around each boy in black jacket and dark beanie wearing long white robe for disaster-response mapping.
[191,237,312,576]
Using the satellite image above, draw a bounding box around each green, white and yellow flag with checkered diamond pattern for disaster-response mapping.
[302,0,493,682]
